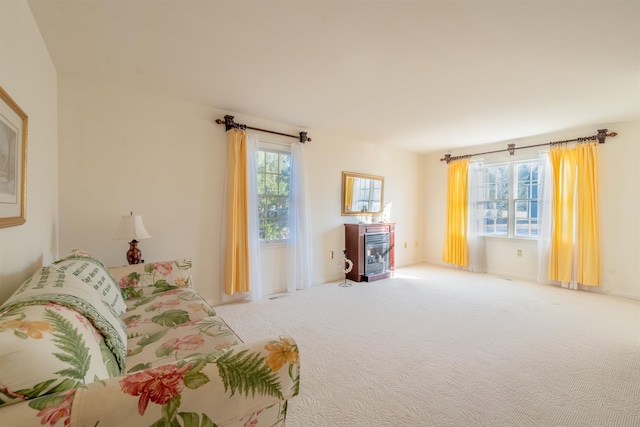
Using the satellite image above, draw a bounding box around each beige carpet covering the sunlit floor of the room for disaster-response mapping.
[216,265,640,427]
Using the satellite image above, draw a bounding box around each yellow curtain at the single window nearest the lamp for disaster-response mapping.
[225,129,250,295]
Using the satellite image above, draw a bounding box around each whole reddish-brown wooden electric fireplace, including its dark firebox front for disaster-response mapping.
[344,222,395,282]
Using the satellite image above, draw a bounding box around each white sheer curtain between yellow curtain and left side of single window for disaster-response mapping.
[221,134,262,302]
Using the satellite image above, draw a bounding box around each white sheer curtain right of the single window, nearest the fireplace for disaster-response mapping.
[287,143,312,292]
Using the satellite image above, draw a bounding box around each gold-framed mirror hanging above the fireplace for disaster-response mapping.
[342,172,384,215]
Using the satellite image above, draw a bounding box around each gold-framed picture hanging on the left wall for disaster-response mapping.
[0,87,29,228]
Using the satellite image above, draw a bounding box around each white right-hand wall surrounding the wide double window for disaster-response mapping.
[423,121,640,299]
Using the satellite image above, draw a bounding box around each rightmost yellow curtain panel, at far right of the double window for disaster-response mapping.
[576,142,600,286]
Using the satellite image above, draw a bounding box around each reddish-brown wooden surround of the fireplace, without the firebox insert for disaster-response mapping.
[344,223,395,282]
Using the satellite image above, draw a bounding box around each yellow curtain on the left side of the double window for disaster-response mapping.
[442,159,469,267]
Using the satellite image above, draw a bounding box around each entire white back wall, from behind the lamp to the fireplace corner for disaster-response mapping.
[59,77,423,302]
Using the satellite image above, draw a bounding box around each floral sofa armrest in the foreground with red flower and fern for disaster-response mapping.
[0,336,300,427]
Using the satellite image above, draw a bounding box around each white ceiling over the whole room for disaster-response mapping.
[28,0,640,152]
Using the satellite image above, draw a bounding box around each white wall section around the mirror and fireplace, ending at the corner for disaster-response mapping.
[307,125,423,283]
